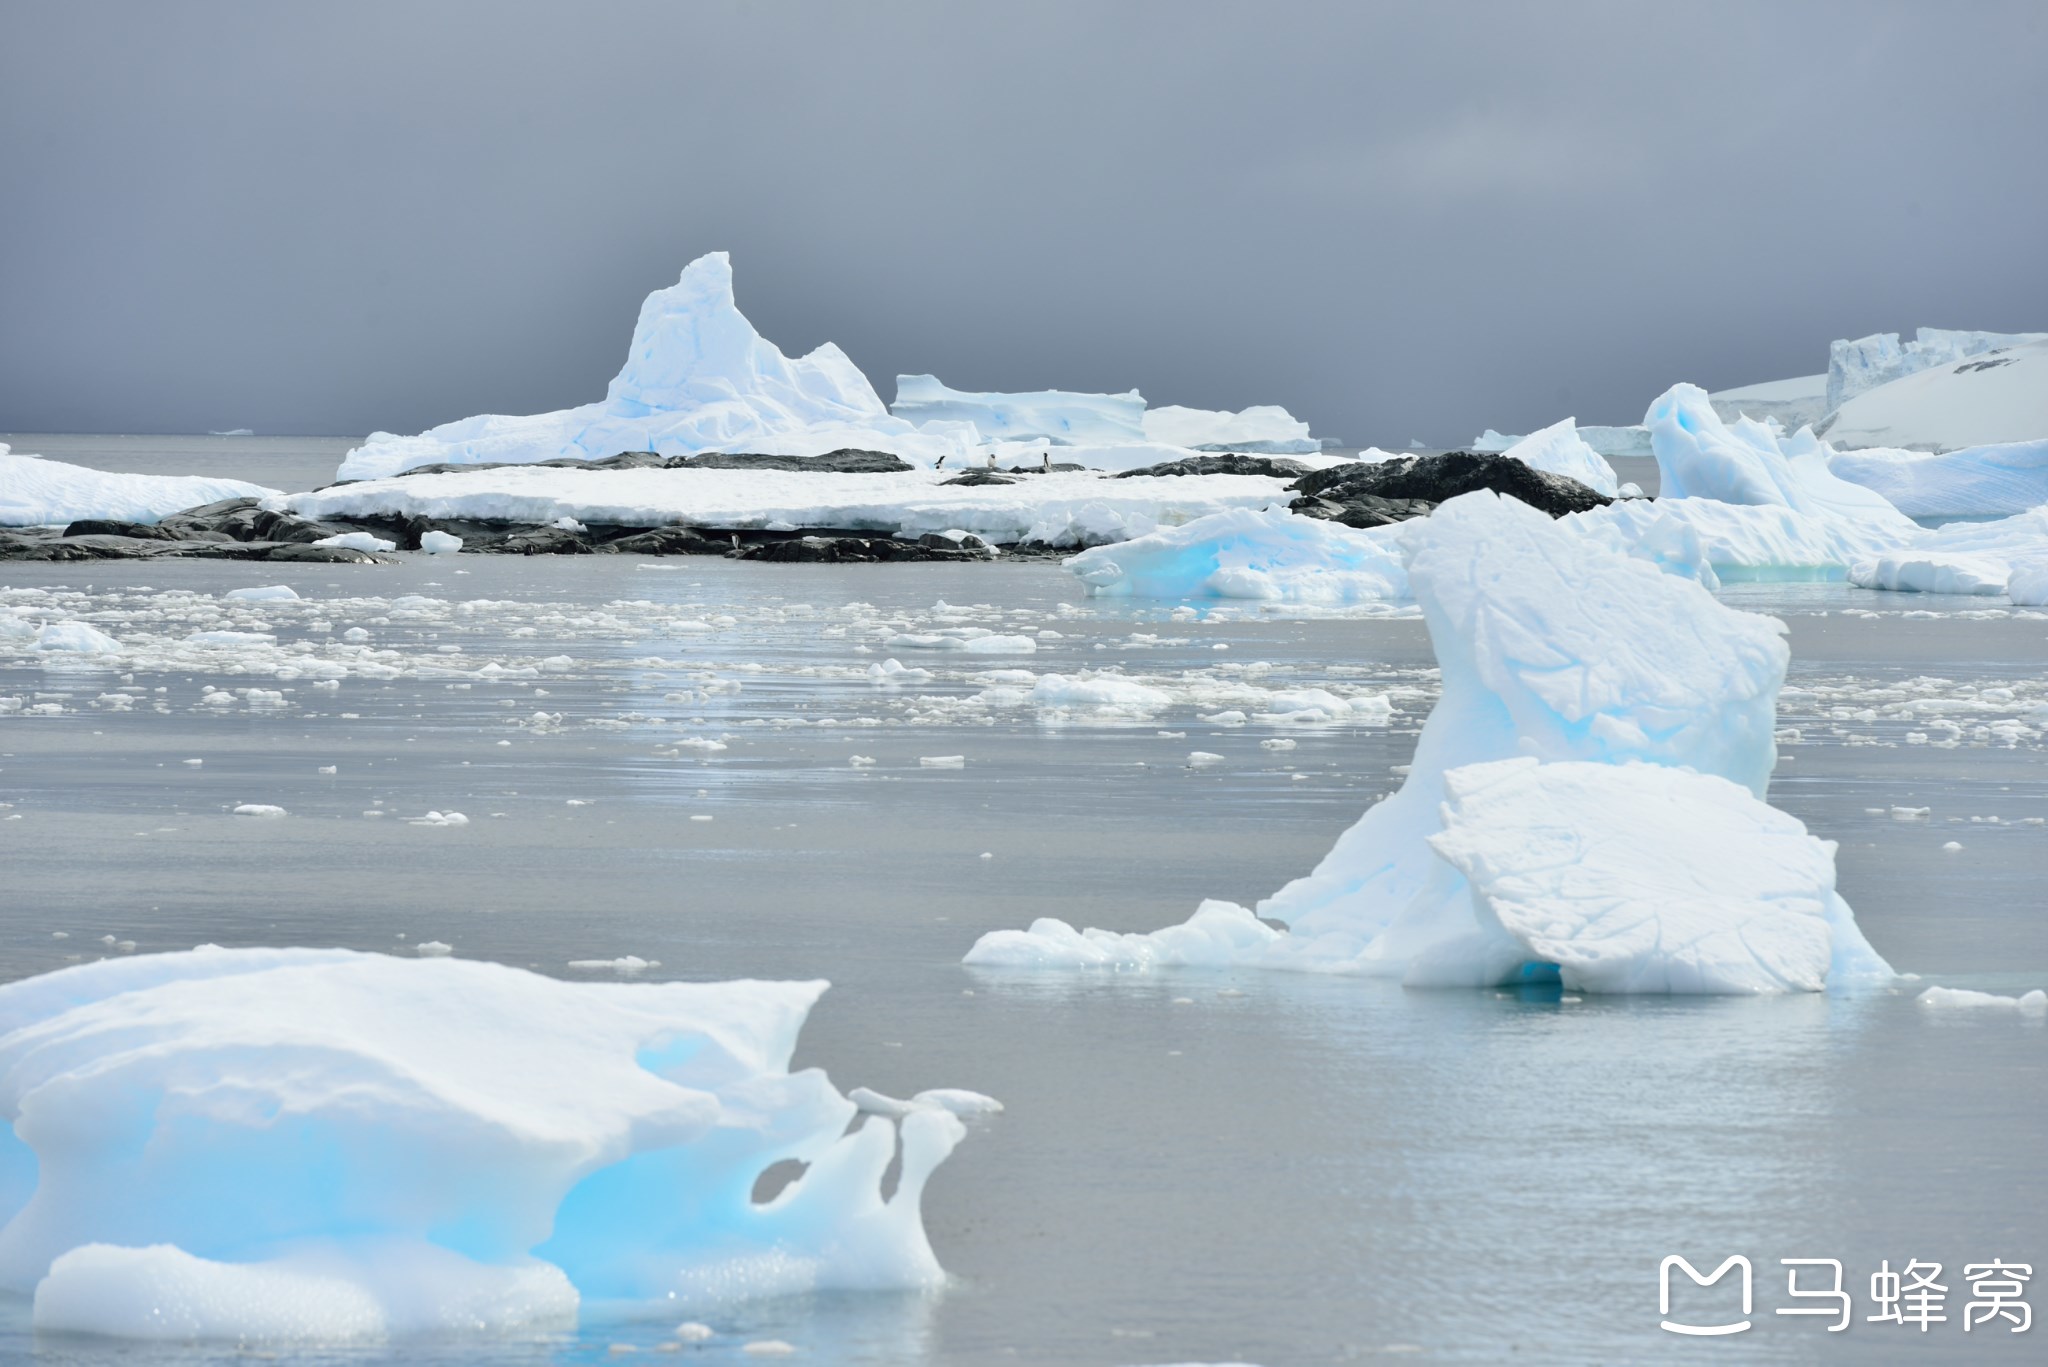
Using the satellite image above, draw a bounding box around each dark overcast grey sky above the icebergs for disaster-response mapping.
[0,0,2048,443]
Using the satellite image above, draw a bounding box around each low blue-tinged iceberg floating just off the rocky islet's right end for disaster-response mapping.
[1065,506,1407,603]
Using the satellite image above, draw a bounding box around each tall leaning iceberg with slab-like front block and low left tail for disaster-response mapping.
[967,494,1890,992]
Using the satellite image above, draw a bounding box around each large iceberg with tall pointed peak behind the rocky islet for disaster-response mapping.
[338,252,975,480]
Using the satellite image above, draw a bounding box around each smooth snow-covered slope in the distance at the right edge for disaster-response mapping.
[1815,334,2048,451]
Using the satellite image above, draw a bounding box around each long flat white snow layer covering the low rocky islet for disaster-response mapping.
[288,465,1288,545]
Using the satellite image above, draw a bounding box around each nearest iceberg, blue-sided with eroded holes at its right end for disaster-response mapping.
[0,949,993,1340]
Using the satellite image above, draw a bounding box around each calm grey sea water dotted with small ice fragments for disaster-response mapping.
[0,447,2048,1367]
